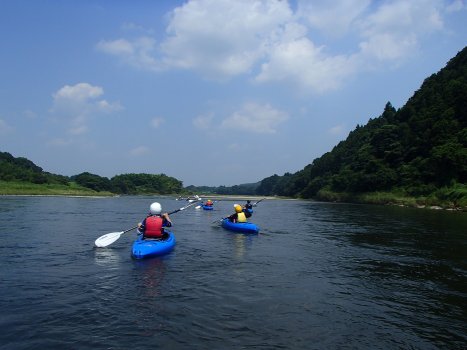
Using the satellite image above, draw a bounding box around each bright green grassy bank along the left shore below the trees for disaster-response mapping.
[0,181,114,197]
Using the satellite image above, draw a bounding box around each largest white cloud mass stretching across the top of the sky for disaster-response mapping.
[97,0,452,93]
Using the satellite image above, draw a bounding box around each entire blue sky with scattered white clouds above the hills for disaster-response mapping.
[0,0,467,186]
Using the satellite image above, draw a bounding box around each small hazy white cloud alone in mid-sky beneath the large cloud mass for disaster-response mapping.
[221,103,288,134]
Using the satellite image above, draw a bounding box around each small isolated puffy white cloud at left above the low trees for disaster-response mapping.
[50,83,122,135]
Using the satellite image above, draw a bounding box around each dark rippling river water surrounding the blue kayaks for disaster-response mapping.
[0,196,467,350]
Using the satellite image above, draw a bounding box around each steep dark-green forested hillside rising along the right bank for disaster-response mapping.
[256,48,467,205]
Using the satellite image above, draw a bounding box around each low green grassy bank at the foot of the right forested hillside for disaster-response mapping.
[316,184,467,211]
